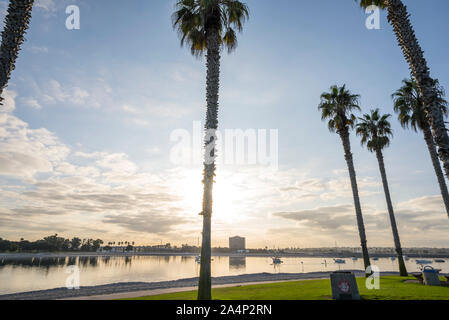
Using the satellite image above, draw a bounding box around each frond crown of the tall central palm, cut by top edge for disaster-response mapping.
[172,0,249,56]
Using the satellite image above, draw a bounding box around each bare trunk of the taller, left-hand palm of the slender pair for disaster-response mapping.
[340,131,371,270]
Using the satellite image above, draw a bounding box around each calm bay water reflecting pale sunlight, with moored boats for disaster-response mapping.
[0,256,449,294]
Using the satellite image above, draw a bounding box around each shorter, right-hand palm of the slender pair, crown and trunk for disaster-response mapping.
[356,109,408,277]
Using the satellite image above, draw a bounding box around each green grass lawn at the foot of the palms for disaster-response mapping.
[122,277,449,300]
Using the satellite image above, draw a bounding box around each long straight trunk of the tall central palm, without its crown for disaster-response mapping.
[198,29,220,300]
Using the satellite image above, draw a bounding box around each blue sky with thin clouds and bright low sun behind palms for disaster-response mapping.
[0,0,449,248]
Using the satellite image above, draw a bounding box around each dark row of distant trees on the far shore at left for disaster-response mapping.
[0,234,103,252]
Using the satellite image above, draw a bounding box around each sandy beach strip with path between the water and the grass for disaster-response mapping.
[0,270,399,300]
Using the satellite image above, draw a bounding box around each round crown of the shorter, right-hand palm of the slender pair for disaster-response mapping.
[356,109,393,152]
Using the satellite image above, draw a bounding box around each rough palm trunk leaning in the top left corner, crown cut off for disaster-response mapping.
[0,0,34,105]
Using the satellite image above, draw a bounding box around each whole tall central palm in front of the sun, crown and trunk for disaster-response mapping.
[172,0,249,300]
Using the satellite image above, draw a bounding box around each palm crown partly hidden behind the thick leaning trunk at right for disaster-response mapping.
[392,79,448,131]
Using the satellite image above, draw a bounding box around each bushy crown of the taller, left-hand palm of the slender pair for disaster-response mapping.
[318,85,360,133]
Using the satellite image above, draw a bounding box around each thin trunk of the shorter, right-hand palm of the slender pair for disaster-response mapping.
[376,150,408,277]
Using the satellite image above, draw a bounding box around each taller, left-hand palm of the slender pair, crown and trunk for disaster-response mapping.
[318,85,370,270]
